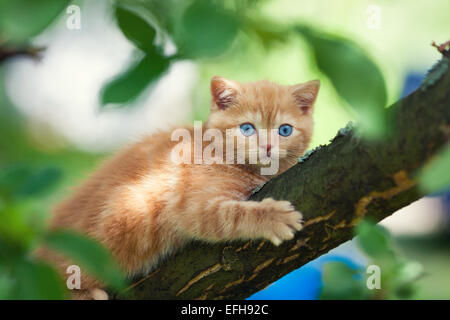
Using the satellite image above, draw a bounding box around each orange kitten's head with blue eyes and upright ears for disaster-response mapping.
[207,77,320,174]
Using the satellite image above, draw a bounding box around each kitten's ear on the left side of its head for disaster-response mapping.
[211,76,239,110]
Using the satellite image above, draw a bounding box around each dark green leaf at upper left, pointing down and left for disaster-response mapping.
[101,52,170,105]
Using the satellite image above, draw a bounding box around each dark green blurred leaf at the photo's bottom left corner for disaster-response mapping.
[11,259,66,300]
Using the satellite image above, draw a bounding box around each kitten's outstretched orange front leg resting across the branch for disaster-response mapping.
[186,197,302,245]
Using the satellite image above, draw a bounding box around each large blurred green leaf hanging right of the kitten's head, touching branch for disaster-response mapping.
[296,26,389,138]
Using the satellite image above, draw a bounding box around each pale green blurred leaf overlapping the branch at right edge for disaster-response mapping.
[418,145,450,192]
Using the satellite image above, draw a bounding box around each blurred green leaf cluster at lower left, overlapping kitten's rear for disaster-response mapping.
[0,165,124,299]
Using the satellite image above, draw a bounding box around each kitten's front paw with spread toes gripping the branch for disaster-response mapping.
[261,198,302,246]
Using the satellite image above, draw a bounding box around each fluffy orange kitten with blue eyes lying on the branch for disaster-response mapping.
[39,77,319,299]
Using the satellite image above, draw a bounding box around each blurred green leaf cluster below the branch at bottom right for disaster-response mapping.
[320,221,423,300]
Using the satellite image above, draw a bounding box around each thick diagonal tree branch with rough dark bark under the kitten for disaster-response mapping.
[114,53,450,299]
